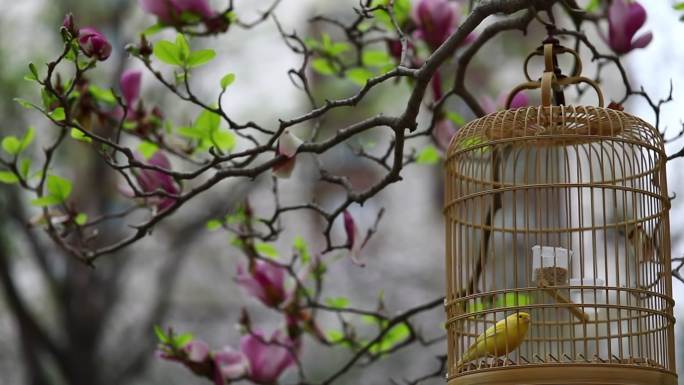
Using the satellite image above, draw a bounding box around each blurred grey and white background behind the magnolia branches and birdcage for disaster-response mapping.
[0,0,684,385]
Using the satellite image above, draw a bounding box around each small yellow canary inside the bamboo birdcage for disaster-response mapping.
[456,312,530,367]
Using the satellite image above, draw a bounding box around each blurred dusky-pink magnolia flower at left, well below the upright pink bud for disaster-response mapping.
[135,151,180,211]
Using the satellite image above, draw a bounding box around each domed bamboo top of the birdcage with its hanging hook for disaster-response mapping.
[448,43,664,155]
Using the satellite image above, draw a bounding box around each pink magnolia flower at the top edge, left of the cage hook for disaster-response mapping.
[411,0,474,51]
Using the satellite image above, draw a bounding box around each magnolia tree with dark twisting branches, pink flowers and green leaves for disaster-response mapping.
[0,0,682,385]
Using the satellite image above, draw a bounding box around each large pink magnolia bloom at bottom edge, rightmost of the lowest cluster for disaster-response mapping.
[240,330,299,384]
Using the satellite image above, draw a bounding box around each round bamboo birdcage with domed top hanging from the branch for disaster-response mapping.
[444,44,677,385]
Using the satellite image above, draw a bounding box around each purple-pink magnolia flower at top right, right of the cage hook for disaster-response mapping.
[608,0,653,54]
